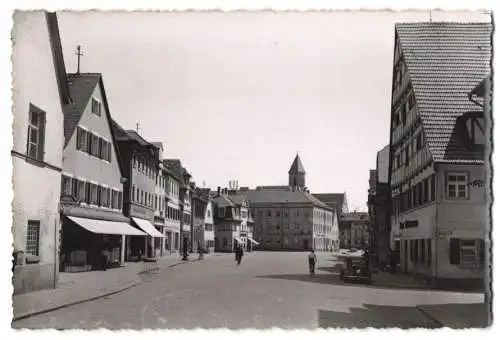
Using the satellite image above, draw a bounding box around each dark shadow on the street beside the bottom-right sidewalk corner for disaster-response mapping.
[318,305,443,329]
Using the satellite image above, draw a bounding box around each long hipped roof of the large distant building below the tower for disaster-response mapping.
[240,189,331,210]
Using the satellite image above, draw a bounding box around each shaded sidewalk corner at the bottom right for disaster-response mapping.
[417,303,490,329]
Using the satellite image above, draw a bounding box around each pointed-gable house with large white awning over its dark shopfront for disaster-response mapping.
[60,73,144,271]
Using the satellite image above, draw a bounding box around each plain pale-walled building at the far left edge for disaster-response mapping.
[11,11,71,294]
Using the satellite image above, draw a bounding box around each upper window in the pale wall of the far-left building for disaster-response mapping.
[26,104,45,161]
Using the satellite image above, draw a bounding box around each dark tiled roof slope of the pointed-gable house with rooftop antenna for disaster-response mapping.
[64,73,101,147]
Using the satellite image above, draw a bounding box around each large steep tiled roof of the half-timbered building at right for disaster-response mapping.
[396,22,492,162]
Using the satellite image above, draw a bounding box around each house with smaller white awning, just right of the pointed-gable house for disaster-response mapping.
[113,121,163,261]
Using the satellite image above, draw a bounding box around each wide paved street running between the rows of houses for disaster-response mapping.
[13,252,482,329]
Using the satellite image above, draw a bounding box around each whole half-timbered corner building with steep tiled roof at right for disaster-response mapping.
[390,23,492,286]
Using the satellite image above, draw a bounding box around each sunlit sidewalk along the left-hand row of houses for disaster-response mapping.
[12,254,201,321]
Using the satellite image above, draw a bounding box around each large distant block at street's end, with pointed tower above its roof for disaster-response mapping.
[241,155,336,251]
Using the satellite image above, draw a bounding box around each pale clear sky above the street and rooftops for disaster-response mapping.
[58,11,489,211]
